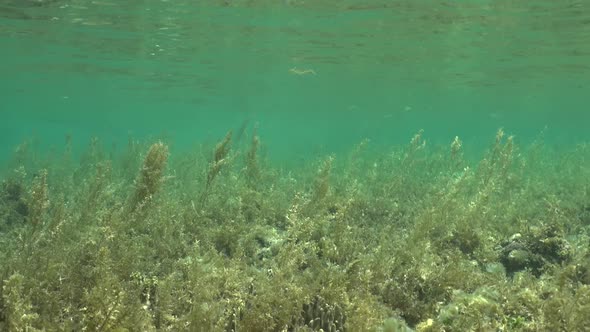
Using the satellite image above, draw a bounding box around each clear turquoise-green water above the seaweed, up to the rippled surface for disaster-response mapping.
[0,0,590,159]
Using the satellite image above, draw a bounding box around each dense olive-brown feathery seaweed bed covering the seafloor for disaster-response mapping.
[0,130,590,332]
